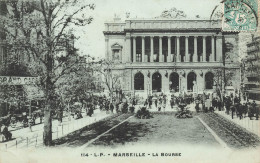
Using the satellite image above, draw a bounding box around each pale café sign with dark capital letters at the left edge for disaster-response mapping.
[0,76,40,85]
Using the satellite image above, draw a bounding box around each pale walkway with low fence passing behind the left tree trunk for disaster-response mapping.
[0,110,110,150]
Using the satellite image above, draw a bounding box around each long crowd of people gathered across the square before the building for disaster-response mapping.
[0,93,259,143]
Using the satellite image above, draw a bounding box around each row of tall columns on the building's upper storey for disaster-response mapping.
[129,35,223,62]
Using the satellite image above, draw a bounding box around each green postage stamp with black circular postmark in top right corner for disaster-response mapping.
[222,0,258,31]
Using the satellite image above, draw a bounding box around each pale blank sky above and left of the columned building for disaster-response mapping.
[72,0,220,59]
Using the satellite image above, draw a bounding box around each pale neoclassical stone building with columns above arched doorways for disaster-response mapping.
[104,18,240,95]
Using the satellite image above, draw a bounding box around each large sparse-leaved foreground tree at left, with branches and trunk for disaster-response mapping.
[0,0,94,146]
